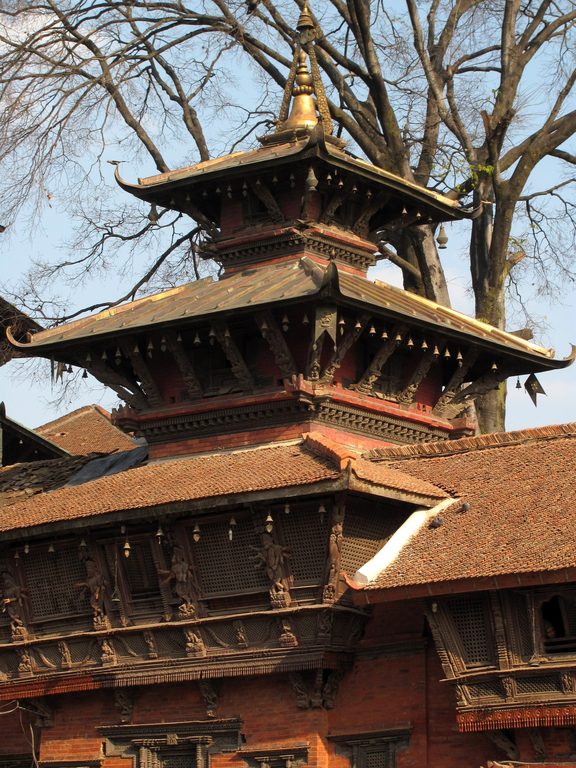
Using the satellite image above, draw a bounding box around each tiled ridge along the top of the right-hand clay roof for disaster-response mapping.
[362,422,576,461]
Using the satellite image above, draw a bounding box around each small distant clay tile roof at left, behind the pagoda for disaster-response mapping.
[35,405,135,455]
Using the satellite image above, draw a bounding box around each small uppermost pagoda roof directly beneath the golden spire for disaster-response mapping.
[115,130,479,225]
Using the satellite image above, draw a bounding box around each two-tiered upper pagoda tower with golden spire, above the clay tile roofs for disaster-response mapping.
[7,12,571,456]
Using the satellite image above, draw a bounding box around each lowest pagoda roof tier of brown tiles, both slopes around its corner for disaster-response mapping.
[0,434,447,537]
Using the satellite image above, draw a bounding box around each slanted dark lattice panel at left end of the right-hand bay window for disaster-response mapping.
[446,595,494,667]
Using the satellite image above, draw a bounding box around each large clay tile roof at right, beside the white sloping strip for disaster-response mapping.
[368,423,576,589]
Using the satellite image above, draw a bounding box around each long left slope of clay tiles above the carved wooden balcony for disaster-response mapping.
[0,445,341,531]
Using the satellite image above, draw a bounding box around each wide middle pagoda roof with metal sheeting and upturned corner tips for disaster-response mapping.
[8,256,576,370]
